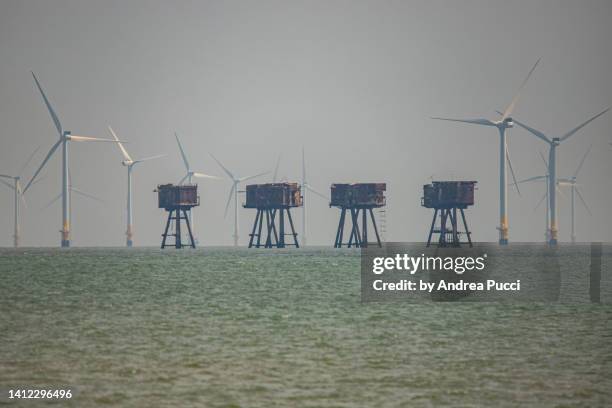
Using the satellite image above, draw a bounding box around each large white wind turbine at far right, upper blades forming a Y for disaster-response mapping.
[514,108,610,245]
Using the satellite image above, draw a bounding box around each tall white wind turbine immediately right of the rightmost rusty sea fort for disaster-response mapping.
[432,59,540,245]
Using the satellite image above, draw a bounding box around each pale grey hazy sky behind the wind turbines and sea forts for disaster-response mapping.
[0,0,612,246]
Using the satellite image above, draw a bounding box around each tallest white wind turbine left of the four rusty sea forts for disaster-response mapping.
[23,72,122,248]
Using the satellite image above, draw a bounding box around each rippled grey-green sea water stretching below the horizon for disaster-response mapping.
[0,246,612,407]
